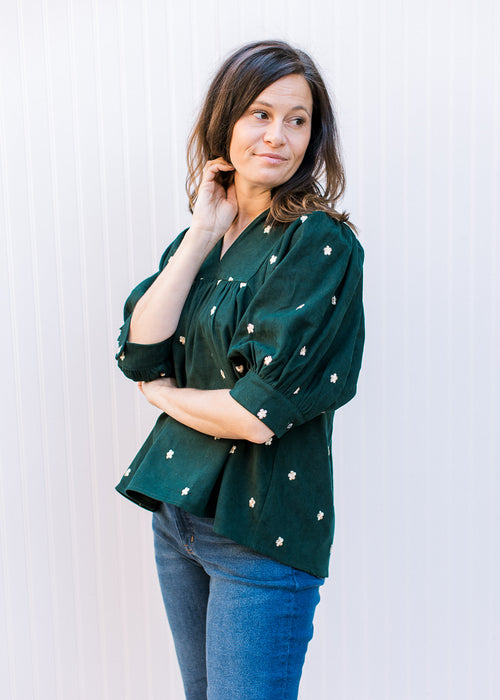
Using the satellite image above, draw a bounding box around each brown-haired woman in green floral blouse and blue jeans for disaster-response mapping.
[117,41,364,700]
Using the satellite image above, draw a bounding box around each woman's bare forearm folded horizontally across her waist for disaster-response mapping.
[138,377,274,444]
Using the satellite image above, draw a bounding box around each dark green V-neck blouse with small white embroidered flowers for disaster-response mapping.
[117,212,364,577]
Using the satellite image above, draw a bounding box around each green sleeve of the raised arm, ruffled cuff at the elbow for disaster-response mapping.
[115,231,185,382]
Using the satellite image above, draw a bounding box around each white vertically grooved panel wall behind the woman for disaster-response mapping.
[0,0,500,700]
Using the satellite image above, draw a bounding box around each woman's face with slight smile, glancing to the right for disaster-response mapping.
[229,75,313,190]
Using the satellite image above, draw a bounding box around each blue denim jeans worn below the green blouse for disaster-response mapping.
[153,503,323,700]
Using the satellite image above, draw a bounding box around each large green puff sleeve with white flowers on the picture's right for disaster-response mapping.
[228,212,364,437]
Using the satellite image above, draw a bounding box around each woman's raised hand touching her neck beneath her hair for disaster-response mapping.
[191,158,238,244]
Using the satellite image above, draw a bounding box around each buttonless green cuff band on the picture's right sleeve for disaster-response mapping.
[230,371,304,438]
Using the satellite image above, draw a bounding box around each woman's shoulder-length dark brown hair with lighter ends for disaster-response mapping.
[186,41,349,223]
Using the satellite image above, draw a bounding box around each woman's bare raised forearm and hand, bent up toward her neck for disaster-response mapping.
[128,158,238,344]
